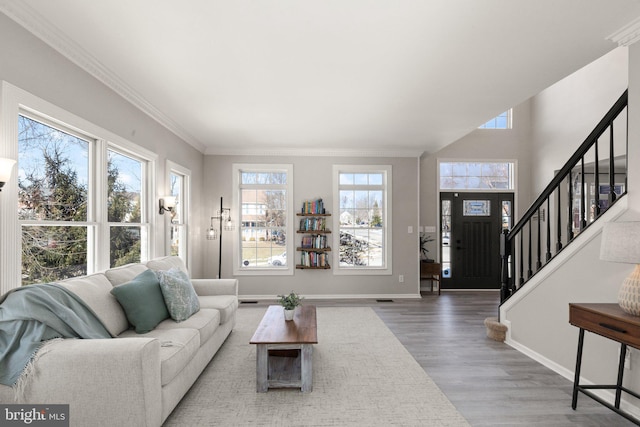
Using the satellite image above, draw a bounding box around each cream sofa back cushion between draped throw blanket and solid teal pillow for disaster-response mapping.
[58,273,129,336]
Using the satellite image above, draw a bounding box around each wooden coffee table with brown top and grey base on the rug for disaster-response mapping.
[250,305,318,392]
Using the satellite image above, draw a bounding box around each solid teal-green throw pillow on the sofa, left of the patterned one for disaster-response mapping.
[111,270,169,334]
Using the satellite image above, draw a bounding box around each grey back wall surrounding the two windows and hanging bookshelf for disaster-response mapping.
[202,155,419,297]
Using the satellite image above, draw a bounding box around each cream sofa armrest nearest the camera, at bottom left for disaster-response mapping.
[18,337,162,426]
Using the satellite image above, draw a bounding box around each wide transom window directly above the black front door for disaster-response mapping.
[439,162,514,191]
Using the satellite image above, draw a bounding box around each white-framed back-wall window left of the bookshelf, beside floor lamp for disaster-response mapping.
[233,165,295,274]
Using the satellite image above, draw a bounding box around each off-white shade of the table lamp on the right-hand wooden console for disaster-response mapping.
[600,221,640,264]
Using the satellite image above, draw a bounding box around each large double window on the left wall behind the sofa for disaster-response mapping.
[17,110,151,285]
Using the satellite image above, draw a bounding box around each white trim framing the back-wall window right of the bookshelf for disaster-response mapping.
[332,164,393,276]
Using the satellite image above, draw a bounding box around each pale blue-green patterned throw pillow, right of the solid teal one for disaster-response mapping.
[156,268,200,322]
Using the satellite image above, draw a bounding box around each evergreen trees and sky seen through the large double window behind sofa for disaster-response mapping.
[18,116,140,285]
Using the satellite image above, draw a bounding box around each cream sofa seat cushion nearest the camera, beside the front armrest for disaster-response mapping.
[120,328,200,386]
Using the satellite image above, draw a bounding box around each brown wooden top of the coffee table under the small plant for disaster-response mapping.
[249,305,318,344]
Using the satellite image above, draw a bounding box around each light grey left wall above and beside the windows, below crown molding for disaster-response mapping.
[0,14,204,277]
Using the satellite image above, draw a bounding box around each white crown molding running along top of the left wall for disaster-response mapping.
[0,0,205,153]
